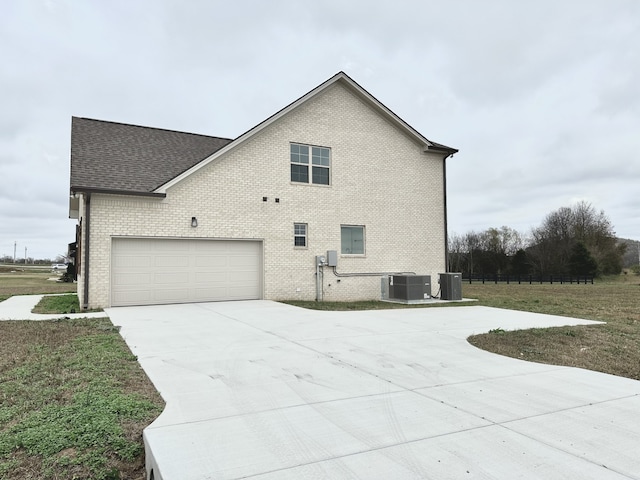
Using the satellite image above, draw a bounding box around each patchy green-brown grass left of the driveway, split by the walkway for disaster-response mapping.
[0,273,164,480]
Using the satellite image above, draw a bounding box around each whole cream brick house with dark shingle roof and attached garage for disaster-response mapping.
[70,72,457,308]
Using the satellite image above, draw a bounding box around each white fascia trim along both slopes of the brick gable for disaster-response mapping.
[154,72,432,194]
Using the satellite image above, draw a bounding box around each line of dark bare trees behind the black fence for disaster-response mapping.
[448,202,626,276]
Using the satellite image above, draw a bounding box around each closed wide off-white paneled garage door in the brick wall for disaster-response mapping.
[111,238,262,306]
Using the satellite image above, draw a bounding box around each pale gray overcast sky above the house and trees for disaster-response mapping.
[0,0,640,258]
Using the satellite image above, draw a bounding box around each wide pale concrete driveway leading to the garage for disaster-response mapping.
[107,301,640,480]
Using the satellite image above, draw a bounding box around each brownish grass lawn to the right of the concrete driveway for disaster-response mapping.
[463,276,640,380]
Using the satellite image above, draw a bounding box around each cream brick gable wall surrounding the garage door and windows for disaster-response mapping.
[81,83,445,307]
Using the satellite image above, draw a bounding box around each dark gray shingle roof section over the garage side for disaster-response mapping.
[71,117,232,194]
